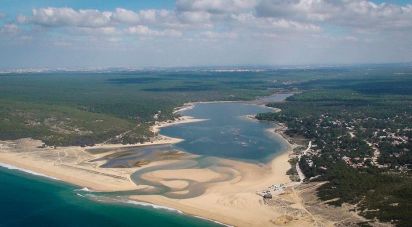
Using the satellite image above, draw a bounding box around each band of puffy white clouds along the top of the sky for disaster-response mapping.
[11,0,412,34]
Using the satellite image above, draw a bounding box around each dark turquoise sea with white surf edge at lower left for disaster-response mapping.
[0,167,222,227]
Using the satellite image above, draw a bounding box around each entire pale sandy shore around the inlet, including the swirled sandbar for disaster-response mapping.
[0,102,350,226]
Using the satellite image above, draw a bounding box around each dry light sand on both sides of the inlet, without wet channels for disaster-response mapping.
[0,95,313,226]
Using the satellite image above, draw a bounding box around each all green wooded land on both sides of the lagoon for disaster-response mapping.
[0,66,412,226]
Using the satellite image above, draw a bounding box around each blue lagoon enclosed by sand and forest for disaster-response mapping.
[161,102,286,162]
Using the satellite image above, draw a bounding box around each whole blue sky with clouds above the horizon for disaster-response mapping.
[0,0,412,69]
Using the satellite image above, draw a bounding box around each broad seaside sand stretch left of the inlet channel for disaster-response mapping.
[0,141,136,191]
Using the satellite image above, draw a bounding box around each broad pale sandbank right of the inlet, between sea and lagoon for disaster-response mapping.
[131,150,298,226]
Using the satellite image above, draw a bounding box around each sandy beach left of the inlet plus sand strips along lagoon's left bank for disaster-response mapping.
[0,111,203,191]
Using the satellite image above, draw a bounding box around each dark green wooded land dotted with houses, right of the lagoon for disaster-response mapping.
[257,69,412,226]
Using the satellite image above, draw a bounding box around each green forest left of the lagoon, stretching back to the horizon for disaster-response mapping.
[0,71,286,146]
